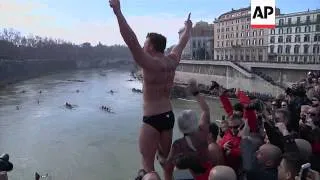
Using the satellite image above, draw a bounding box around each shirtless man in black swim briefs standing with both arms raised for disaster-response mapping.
[109,0,192,176]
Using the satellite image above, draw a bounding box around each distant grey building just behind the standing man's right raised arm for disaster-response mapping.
[179,21,214,60]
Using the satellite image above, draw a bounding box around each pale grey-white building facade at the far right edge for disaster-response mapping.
[268,9,320,63]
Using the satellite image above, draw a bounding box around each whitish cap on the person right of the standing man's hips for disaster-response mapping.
[178,110,198,134]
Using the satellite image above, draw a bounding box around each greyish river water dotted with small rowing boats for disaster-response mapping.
[0,69,230,180]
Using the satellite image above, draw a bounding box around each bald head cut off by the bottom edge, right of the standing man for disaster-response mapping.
[209,166,237,180]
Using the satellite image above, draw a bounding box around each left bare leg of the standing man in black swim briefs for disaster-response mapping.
[139,123,160,173]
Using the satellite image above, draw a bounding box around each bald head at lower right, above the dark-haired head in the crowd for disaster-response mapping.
[257,144,281,167]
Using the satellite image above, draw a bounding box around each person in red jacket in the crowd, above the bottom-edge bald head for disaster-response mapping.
[218,115,244,172]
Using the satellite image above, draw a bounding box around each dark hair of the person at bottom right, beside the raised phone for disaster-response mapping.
[282,153,305,177]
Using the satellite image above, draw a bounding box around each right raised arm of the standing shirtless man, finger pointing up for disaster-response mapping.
[169,13,192,63]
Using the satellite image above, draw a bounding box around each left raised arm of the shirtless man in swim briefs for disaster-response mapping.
[109,0,165,70]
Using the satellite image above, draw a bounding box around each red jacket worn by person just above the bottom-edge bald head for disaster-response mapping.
[218,130,241,172]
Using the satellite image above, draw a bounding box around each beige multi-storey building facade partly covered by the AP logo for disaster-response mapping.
[214,7,280,62]
